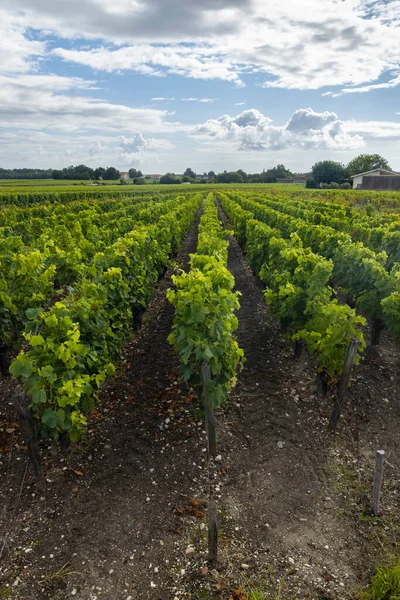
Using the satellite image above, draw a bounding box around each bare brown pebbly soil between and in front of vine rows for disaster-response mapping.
[0,207,400,600]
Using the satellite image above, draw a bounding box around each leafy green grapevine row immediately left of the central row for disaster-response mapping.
[10,194,202,440]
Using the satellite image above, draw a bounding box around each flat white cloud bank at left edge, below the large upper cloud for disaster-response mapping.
[0,75,187,132]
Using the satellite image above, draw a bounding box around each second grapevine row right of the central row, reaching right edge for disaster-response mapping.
[220,193,400,343]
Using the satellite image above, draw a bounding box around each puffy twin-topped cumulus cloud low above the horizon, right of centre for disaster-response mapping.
[192,108,364,150]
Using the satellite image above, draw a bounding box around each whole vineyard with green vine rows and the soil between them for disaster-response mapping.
[0,185,400,600]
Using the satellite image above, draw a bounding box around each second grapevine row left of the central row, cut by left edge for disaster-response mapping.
[0,196,195,370]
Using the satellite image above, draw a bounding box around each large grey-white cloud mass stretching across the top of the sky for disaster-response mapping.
[6,0,400,89]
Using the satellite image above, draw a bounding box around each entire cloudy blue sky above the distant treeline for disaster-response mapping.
[0,0,400,173]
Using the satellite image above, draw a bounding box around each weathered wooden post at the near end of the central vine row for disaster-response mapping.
[201,363,218,563]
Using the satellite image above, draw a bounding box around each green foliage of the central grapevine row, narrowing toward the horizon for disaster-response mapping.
[167,194,244,407]
